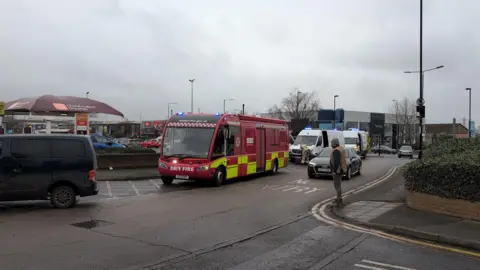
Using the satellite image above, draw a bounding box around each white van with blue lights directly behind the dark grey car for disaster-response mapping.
[289,129,345,162]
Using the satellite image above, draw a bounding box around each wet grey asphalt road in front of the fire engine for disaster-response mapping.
[0,156,480,270]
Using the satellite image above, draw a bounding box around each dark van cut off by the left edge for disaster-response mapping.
[0,134,98,208]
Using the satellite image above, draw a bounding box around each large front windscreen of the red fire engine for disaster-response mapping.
[162,127,214,158]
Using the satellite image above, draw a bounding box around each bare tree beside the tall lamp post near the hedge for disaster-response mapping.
[390,97,418,144]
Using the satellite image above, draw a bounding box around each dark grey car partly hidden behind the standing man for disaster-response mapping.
[307,147,362,180]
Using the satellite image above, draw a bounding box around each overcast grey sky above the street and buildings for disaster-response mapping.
[0,0,480,123]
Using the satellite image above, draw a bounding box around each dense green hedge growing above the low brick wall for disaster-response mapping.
[404,138,480,202]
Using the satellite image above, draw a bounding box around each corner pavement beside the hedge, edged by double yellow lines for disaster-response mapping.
[332,172,480,251]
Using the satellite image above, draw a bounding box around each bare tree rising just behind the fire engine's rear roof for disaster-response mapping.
[268,89,320,120]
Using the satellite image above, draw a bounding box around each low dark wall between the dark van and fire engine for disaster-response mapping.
[97,153,160,170]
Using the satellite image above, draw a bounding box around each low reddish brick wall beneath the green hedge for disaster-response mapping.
[407,191,480,221]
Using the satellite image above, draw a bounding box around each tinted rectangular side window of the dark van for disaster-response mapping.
[10,139,50,158]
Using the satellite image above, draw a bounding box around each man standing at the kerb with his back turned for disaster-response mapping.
[330,138,347,207]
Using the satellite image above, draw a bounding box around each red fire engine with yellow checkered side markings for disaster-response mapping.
[158,113,289,186]
